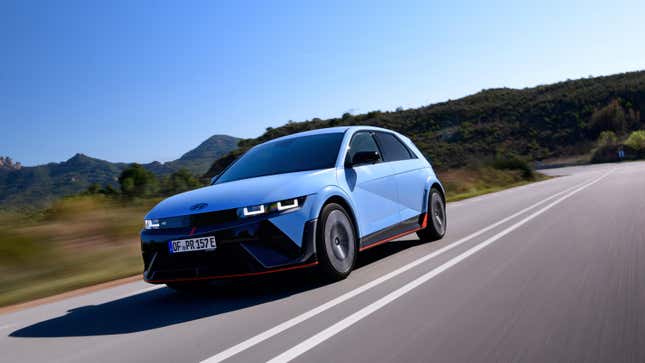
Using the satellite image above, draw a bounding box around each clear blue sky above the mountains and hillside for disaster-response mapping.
[0,0,645,165]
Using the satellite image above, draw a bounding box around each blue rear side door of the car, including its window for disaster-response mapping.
[374,131,428,222]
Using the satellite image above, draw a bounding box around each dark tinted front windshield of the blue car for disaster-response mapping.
[216,132,344,184]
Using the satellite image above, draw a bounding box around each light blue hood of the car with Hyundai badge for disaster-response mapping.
[145,169,336,219]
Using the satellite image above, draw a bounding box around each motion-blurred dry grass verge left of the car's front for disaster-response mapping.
[0,197,154,306]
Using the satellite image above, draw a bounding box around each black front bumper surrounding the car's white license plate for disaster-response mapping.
[141,218,317,283]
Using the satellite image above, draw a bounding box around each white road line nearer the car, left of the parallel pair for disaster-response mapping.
[197,177,600,363]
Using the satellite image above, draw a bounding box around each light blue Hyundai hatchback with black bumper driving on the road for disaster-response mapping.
[141,126,446,288]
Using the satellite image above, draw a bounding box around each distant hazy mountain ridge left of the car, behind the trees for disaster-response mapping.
[0,135,239,207]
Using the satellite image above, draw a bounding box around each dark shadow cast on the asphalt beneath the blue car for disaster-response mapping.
[9,240,420,338]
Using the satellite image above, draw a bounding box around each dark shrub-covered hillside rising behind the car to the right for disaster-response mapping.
[205,71,645,176]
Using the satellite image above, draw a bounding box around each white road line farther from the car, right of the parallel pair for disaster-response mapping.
[268,170,613,363]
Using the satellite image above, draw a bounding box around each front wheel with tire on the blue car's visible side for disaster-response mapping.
[316,203,358,281]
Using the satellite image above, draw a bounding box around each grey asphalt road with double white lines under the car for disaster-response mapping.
[0,163,645,362]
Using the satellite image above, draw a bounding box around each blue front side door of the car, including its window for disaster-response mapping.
[340,131,400,237]
